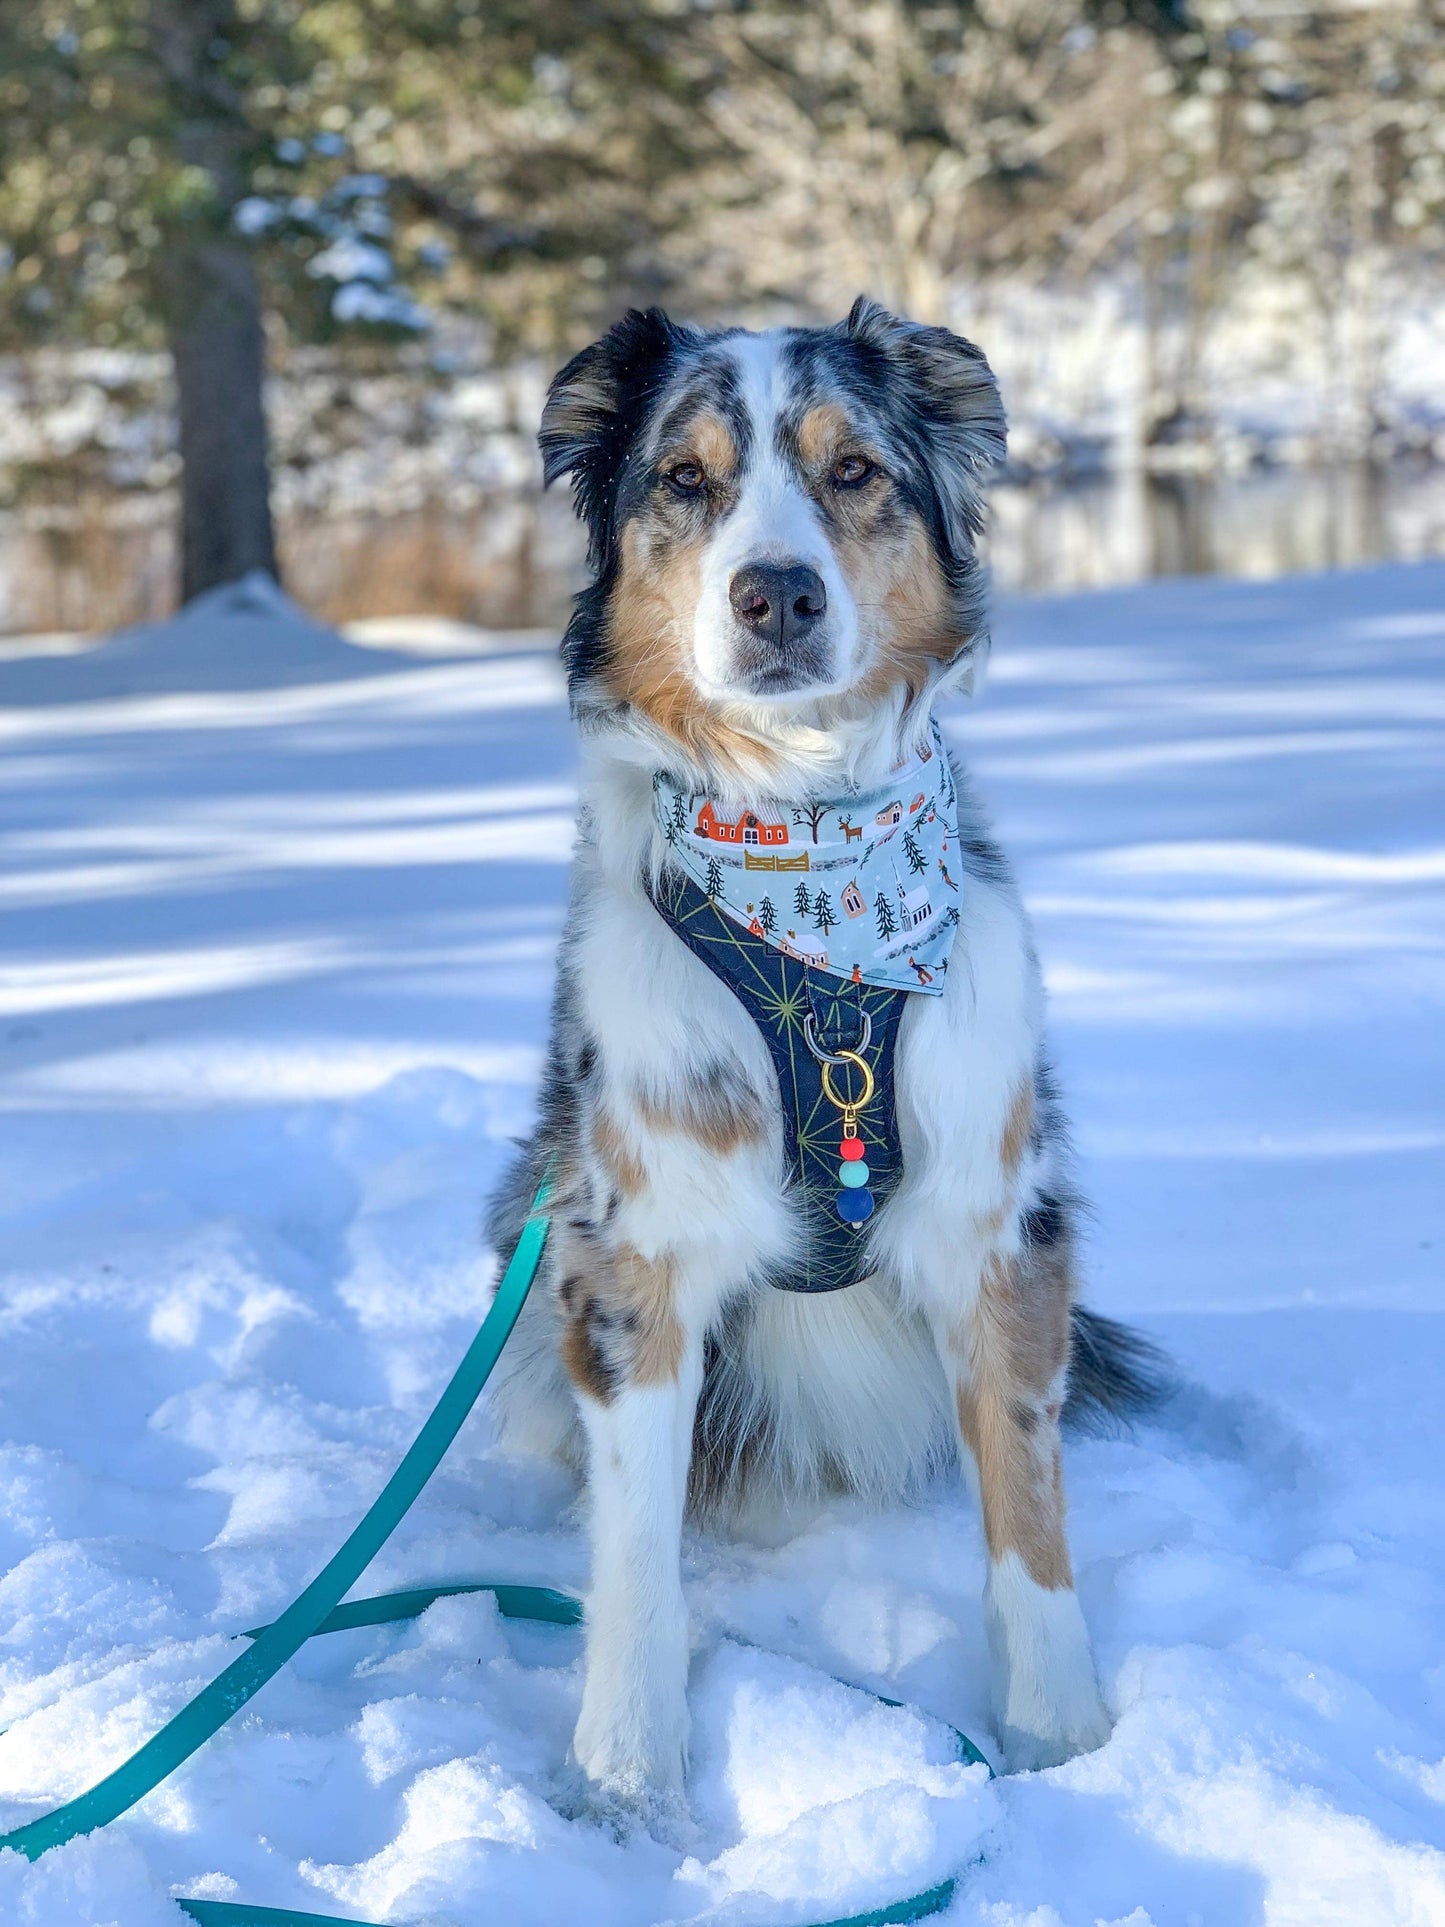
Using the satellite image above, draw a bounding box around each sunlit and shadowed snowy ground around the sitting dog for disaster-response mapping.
[0,567,1445,1927]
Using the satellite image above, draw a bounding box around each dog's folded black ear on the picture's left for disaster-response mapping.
[538,308,692,572]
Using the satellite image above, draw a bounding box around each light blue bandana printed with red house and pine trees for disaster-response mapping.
[653,725,961,996]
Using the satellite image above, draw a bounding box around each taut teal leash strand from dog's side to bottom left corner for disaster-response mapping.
[0,1172,551,1860]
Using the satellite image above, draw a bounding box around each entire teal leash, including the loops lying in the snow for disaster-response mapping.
[0,1168,992,1927]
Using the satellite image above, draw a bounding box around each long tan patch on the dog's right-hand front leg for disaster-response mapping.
[950,1253,1073,1592]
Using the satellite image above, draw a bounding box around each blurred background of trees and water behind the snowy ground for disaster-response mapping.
[0,0,1445,632]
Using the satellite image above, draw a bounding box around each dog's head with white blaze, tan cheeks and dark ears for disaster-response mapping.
[541,301,1004,767]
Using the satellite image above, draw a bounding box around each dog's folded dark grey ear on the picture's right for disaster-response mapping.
[842,295,1008,559]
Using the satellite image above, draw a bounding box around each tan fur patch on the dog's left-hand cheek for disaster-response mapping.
[605,513,776,782]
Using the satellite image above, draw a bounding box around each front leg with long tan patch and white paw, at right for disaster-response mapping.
[938,1249,1110,1769]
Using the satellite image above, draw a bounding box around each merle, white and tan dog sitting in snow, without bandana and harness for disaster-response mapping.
[489,299,1154,1831]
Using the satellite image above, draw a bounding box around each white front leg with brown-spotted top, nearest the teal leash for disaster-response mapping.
[561,1243,703,1823]
